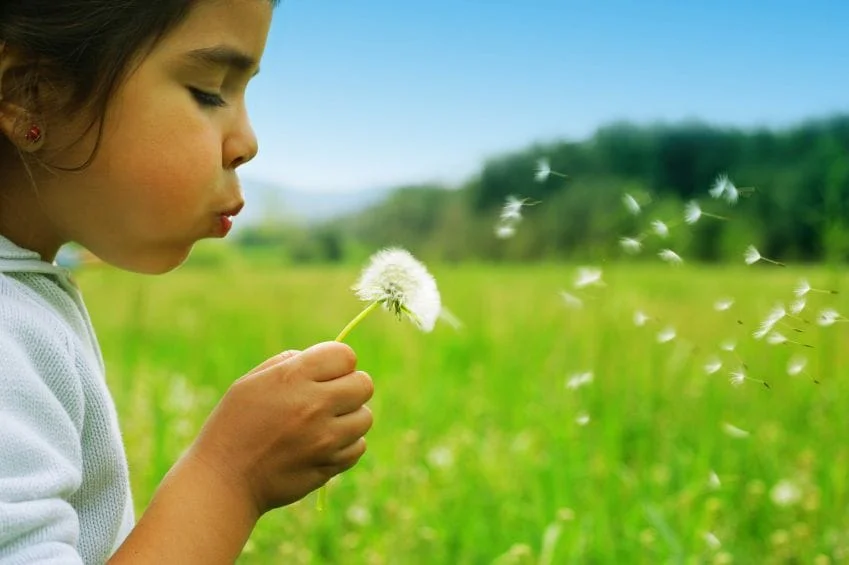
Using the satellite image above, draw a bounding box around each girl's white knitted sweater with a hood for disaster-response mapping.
[0,237,134,565]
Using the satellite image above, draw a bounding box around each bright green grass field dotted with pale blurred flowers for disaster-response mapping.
[80,256,849,565]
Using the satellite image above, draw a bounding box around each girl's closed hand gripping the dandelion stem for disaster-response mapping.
[187,342,374,514]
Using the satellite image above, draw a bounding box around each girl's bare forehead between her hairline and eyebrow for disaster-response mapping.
[152,0,272,66]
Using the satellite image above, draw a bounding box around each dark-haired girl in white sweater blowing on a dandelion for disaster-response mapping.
[0,0,372,564]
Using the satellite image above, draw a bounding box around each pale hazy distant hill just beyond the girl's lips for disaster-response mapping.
[236,179,392,226]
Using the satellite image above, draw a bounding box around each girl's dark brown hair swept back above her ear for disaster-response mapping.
[0,0,279,167]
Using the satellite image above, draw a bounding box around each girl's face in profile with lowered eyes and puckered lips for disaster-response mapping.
[39,0,272,273]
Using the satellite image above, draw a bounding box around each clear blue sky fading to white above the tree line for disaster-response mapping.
[242,0,849,192]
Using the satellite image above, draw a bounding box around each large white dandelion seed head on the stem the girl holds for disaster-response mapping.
[353,248,442,332]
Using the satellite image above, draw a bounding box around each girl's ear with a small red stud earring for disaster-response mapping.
[0,43,44,153]
